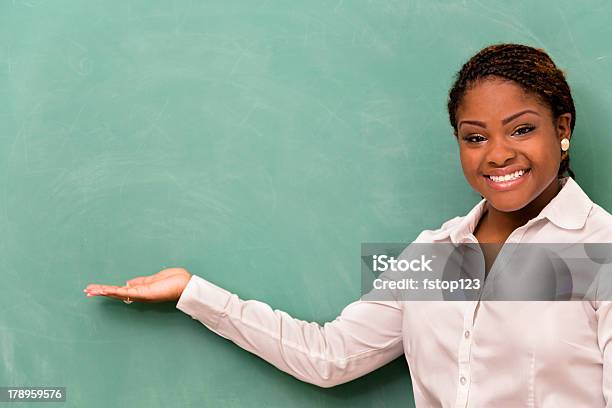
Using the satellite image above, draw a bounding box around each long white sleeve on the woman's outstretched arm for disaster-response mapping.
[176,275,403,387]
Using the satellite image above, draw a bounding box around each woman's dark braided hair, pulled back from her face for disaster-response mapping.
[448,44,576,178]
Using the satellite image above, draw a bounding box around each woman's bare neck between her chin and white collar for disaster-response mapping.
[483,179,561,235]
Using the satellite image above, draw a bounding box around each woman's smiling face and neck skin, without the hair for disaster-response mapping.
[456,78,571,242]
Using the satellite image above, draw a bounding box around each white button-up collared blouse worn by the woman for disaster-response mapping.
[176,178,612,408]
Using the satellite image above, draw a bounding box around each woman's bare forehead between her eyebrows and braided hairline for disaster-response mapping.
[457,78,550,119]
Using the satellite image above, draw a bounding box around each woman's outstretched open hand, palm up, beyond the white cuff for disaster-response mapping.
[83,268,191,303]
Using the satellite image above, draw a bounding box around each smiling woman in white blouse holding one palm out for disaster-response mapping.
[85,44,612,407]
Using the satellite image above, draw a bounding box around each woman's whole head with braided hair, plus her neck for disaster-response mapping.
[448,44,576,243]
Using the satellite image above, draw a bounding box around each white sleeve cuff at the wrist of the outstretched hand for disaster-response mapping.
[176,275,232,330]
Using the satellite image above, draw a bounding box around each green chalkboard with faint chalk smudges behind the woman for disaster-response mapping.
[0,0,612,408]
